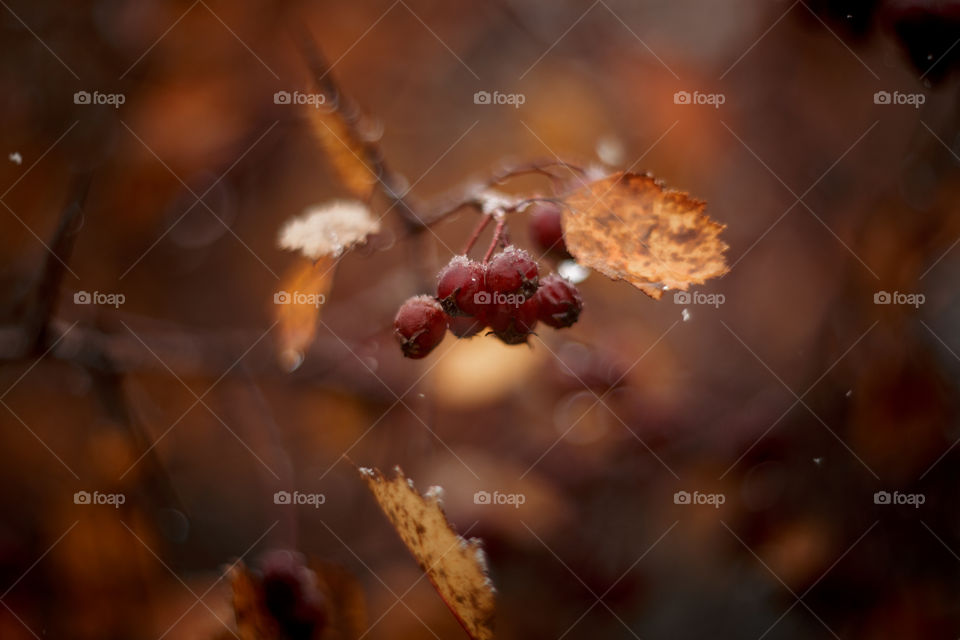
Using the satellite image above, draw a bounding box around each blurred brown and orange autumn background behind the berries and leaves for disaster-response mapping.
[0,0,960,639]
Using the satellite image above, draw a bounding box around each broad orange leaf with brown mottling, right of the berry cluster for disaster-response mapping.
[563,172,728,300]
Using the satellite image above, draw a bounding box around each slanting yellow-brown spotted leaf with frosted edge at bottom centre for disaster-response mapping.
[360,467,494,640]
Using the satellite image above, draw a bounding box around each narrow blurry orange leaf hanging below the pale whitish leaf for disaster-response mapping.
[273,258,334,371]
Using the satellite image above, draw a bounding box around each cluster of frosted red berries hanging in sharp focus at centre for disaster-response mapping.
[394,238,583,359]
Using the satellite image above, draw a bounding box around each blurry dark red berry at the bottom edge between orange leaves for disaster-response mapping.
[260,550,329,640]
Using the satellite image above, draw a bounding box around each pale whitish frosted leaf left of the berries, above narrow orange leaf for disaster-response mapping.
[278,200,380,260]
